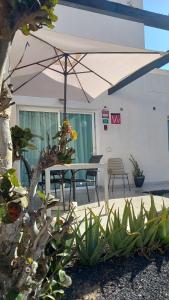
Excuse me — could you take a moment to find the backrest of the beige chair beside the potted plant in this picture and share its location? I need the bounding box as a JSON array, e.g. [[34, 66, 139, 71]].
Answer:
[[107, 158, 126, 175]]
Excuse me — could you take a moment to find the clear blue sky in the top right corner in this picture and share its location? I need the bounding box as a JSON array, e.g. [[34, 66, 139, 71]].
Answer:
[[144, 0, 169, 51]]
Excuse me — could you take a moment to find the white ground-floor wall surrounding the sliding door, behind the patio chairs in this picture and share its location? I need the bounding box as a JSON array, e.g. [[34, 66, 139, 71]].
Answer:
[[13, 71, 169, 183]]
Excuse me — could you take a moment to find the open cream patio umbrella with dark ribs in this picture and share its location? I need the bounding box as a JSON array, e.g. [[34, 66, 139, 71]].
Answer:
[[10, 29, 165, 118]]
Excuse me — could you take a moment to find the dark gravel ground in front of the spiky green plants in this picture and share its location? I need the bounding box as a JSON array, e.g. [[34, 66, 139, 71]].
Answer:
[[65, 253, 169, 300]]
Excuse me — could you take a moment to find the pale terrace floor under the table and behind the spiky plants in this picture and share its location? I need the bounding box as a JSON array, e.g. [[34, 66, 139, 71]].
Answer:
[[48, 183, 169, 220]]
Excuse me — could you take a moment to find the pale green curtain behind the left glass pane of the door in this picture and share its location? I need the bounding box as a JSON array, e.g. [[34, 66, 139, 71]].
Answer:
[[19, 111, 58, 186]]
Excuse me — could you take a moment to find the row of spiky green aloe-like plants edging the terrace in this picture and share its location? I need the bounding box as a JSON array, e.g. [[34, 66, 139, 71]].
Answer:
[[73, 196, 169, 265]]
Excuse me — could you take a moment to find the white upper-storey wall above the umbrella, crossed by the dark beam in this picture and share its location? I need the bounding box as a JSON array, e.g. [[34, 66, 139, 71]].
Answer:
[[54, 0, 144, 48]]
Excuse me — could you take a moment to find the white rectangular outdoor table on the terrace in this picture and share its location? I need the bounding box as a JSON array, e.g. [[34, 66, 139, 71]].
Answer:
[[45, 163, 109, 207]]
